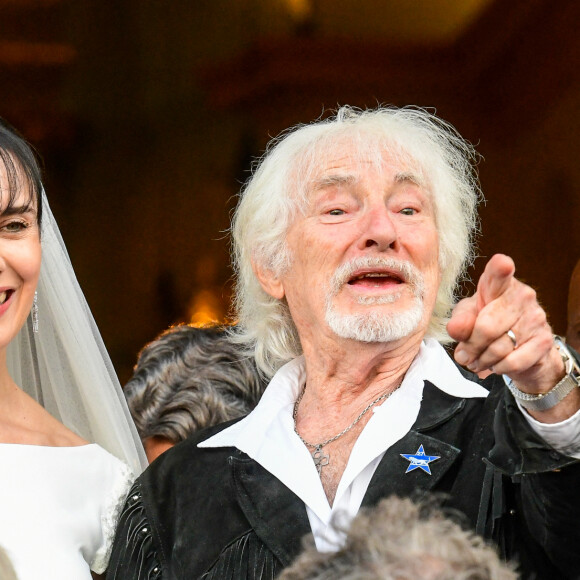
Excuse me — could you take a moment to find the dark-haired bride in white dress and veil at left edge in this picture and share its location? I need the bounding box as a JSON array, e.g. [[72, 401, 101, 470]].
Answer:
[[0, 120, 145, 580]]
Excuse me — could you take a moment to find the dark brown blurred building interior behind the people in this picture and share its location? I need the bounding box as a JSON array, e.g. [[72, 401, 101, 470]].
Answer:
[[0, 0, 580, 382]]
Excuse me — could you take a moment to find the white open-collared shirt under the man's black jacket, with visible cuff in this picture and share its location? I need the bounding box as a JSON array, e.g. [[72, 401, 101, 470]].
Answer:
[[199, 339, 580, 551]]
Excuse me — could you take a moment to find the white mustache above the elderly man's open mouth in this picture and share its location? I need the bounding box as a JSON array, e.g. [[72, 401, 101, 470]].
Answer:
[[330, 256, 425, 298]]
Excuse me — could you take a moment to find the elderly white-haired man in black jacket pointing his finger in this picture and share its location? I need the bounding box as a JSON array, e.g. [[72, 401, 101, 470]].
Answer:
[[108, 107, 580, 580]]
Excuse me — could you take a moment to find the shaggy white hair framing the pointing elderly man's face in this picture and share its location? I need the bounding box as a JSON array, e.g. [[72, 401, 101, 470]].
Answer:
[[232, 107, 481, 376]]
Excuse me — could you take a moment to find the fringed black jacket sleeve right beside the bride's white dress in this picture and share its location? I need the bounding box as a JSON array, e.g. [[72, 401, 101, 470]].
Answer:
[[107, 481, 164, 580]]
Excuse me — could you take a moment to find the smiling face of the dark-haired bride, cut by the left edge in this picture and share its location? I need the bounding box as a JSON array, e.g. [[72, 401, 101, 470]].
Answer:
[[0, 156, 41, 350]]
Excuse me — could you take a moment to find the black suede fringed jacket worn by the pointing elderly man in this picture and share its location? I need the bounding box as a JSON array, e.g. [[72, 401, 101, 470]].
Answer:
[[107, 375, 580, 580]]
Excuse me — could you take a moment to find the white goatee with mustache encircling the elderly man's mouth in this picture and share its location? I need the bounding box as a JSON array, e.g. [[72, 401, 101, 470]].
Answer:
[[326, 257, 424, 342]]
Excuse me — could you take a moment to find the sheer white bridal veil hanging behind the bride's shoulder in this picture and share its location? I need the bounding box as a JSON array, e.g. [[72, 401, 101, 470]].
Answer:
[[8, 192, 147, 475]]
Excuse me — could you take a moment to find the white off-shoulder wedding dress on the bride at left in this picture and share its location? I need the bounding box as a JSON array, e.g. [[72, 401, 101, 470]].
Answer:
[[0, 444, 133, 580]]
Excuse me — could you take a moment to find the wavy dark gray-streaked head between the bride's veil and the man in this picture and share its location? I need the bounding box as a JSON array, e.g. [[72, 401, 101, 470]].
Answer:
[[124, 325, 265, 461]]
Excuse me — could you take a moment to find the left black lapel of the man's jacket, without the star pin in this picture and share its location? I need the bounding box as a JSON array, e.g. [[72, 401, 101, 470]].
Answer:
[[230, 457, 311, 566]]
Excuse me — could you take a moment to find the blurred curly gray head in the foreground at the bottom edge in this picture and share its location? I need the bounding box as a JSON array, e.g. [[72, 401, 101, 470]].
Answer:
[[279, 496, 518, 580]]
